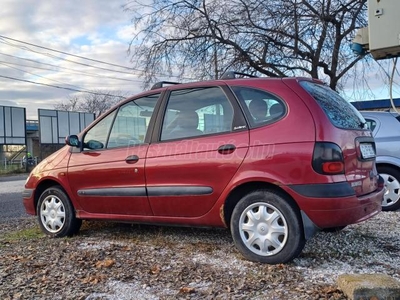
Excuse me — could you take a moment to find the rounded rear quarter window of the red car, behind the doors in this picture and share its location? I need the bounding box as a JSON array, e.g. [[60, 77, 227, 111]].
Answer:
[[231, 86, 286, 127]]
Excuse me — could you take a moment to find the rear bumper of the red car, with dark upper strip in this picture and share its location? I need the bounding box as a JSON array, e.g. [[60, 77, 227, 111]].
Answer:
[[289, 183, 384, 229]]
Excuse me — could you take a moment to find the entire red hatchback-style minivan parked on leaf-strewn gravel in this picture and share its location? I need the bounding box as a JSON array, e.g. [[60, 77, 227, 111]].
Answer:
[[23, 74, 384, 264]]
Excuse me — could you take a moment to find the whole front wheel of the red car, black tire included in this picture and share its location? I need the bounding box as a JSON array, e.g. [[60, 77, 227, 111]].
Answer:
[[37, 186, 82, 237]]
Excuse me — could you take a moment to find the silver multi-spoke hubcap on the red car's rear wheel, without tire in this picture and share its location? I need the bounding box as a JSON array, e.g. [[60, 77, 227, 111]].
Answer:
[[239, 202, 288, 256]]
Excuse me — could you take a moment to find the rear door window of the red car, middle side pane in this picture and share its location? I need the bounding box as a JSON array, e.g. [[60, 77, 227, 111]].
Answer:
[[161, 87, 233, 140]]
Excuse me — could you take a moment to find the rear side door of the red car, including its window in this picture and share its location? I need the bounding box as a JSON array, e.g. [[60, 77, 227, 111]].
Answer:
[[146, 86, 249, 217]]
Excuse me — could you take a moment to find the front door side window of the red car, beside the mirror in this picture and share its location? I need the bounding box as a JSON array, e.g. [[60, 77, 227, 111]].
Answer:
[[83, 94, 159, 149]]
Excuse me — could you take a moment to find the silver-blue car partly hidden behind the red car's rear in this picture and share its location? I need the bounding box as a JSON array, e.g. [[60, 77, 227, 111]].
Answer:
[[361, 111, 400, 211]]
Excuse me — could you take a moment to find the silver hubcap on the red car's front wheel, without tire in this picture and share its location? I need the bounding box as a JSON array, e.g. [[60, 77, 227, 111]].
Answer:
[[40, 195, 65, 233]]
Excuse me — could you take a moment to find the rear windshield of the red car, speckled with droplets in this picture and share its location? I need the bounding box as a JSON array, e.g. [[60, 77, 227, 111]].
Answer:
[[300, 81, 367, 129]]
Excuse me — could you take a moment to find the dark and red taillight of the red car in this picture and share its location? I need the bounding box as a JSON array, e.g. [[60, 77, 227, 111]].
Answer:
[[312, 142, 344, 175]]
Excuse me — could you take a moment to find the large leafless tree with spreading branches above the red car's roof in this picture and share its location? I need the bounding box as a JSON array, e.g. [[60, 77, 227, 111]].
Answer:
[[124, 0, 367, 89]]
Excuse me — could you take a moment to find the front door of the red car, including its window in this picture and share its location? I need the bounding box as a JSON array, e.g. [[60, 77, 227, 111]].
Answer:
[[68, 94, 159, 215]]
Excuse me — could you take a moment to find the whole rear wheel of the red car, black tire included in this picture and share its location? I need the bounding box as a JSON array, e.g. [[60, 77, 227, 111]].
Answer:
[[230, 190, 305, 264]]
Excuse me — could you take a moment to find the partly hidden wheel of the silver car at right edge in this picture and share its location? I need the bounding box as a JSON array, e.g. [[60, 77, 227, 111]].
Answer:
[[377, 166, 400, 211]]
